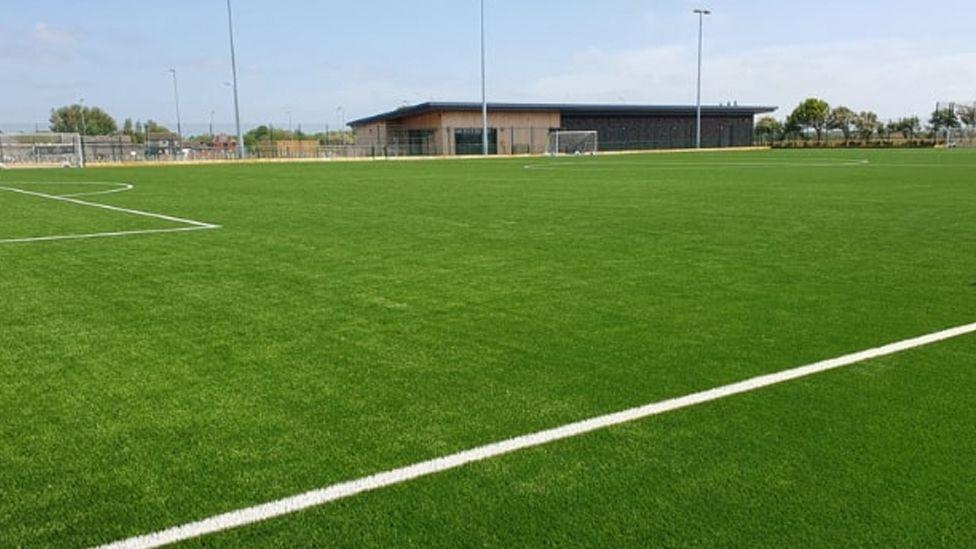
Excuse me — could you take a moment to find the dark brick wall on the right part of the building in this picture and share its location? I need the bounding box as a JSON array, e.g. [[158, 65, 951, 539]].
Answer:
[[562, 115, 753, 151]]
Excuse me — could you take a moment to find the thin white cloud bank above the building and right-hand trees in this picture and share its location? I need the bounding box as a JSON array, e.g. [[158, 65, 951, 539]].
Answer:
[[519, 40, 976, 118]]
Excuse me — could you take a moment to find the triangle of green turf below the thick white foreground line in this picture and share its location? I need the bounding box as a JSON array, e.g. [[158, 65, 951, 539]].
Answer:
[[202, 340, 976, 547]]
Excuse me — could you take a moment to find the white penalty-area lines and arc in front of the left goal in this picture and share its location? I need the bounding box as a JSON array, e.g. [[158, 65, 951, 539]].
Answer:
[[0, 182, 220, 244]]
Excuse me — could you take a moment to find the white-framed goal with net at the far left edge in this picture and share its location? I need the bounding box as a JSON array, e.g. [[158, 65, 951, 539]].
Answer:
[[0, 133, 85, 168]]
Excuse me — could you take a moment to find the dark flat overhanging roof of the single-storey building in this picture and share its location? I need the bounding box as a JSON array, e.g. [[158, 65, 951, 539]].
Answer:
[[349, 102, 776, 127]]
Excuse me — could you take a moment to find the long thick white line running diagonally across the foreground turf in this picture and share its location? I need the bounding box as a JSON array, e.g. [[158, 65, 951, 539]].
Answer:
[[100, 323, 976, 549]]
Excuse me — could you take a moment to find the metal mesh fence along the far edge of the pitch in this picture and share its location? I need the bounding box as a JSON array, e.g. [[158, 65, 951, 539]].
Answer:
[[11, 122, 964, 166]]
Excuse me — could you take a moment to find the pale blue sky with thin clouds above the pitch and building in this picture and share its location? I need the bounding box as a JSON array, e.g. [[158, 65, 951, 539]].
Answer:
[[0, 0, 976, 133]]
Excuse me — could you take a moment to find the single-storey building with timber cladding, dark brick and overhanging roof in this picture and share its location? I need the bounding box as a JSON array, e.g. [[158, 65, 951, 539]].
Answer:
[[350, 102, 776, 156]]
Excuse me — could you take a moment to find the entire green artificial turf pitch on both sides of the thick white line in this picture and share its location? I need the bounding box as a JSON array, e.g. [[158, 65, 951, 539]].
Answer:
[[0, 151, 976, 546]]
